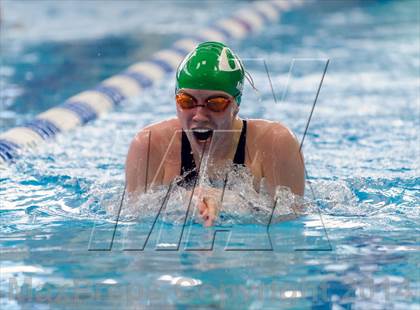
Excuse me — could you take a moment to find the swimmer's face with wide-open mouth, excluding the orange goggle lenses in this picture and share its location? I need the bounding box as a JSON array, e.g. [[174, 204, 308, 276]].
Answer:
[[176, 88, 239, 141]]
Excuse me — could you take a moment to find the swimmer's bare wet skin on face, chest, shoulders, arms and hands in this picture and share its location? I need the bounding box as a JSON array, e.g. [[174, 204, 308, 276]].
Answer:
[[126, 89, 305, 226]]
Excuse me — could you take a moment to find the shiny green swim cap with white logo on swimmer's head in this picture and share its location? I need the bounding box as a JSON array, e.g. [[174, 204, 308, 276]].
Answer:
[[176, 42, 245, 105]]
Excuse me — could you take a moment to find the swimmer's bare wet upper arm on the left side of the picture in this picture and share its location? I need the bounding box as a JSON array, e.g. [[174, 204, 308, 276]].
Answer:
[[125, 130, 163, 193]]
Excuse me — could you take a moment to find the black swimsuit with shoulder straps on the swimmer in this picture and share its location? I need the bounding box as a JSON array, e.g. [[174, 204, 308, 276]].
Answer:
[[178, 120, 246, 187]]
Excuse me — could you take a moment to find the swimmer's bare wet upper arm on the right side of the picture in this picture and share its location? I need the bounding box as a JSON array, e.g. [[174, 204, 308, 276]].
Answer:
[[262, 124, 305, 197]]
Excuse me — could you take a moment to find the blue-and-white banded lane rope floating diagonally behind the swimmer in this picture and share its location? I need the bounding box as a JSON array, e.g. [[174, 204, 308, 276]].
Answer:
[[0, 0, 306, 164]]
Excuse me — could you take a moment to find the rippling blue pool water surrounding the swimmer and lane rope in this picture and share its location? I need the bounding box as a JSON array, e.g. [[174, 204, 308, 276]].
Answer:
[[0, 1, 420, 309]]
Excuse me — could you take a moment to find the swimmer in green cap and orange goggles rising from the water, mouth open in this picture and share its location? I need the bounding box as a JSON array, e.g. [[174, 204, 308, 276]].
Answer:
[[126, 42, 305, 226]]
